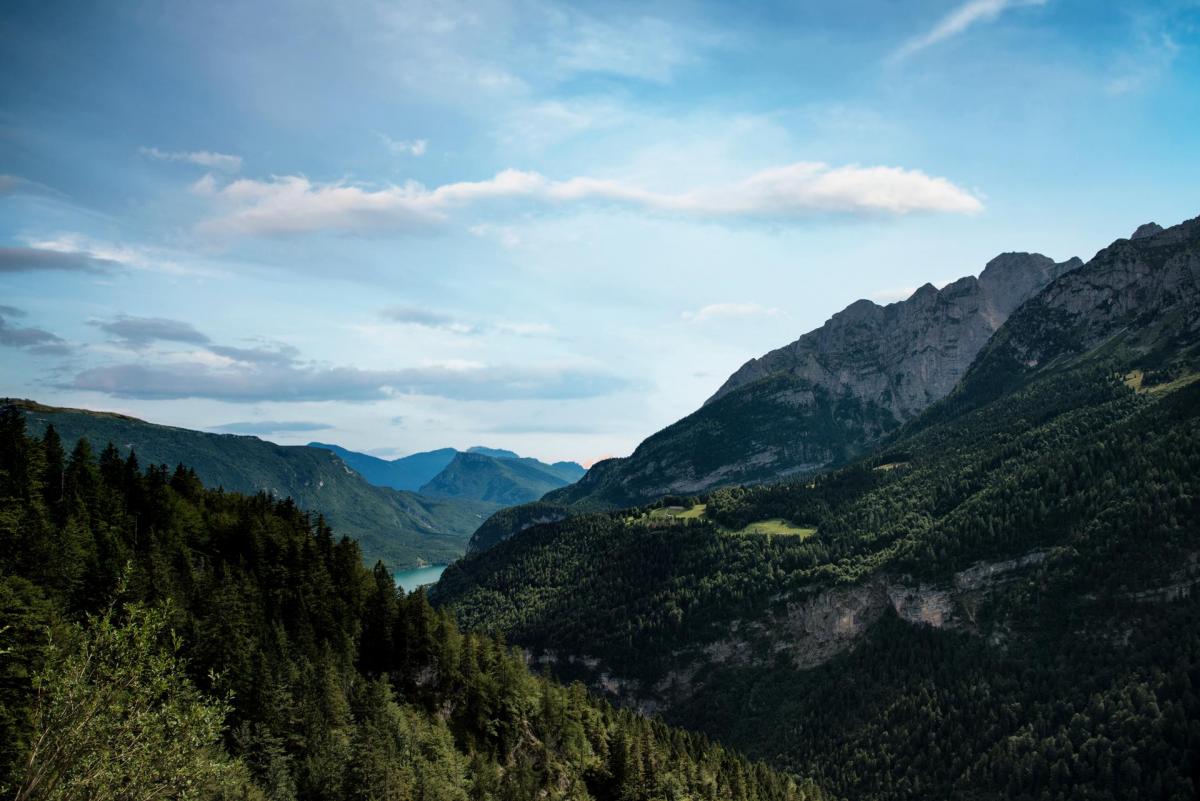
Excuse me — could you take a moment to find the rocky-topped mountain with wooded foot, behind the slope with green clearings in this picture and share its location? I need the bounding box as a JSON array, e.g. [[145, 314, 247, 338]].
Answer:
[[542, 253, 1082, 511]]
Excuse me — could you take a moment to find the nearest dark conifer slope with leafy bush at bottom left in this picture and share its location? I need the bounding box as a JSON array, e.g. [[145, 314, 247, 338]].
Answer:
[[0, 405, 823, 801]]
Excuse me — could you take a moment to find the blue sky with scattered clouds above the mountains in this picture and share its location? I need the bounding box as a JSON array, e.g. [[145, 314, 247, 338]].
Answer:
[[0, 0, 1200, 464]]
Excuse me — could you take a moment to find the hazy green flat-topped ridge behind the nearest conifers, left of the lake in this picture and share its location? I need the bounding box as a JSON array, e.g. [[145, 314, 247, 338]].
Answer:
[[10, 401, 498, 568]]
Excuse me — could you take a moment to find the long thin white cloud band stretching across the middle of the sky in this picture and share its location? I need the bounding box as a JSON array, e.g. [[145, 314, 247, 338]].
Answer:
[[200, 162, 983, 236]]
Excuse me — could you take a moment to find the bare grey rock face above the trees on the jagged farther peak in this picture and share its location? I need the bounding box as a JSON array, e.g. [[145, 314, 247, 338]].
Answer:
[[707, 253, 1082, 422]]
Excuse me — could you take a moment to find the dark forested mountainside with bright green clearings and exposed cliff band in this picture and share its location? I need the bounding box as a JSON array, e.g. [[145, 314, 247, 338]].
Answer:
[[433, 215, 1200, 799]]
